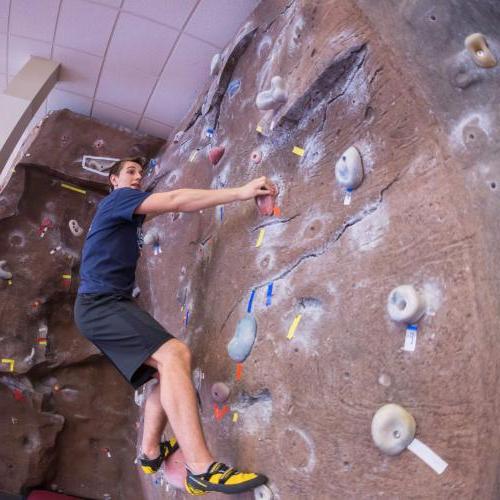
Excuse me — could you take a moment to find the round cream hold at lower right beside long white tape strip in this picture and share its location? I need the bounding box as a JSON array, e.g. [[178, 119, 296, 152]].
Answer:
[[372, 403, 416, 455]]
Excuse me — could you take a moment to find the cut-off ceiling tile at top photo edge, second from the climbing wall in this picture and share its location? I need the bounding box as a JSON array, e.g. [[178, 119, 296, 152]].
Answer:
[[122, 0, 196, 29]]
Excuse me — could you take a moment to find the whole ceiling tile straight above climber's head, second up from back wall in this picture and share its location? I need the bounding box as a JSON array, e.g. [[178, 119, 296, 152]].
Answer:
[[96, 68, 156, 113]]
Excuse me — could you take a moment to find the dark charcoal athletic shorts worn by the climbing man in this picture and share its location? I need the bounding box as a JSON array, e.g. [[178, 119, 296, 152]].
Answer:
[[74, 293, 174, 389]]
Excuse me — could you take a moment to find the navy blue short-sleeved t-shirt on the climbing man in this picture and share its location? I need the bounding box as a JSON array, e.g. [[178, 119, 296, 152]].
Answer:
[[78, 188, 151, 294]]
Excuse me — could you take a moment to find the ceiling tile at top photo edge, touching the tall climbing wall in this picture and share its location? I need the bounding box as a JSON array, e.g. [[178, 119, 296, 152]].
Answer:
[[185, 0, 259, 47]]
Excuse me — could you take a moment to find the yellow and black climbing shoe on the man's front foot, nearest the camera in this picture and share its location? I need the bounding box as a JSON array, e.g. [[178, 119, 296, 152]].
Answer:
[[185, 462, 267, 495]]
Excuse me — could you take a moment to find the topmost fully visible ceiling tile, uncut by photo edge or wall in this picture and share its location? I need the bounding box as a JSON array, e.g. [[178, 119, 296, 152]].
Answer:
[[105, 13, 178, 76]]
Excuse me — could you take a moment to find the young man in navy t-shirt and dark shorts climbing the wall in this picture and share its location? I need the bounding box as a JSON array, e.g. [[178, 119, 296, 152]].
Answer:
[[75, 158, 275, 495]]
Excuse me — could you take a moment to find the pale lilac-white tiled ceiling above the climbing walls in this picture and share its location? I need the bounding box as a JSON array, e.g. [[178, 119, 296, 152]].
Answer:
[[0, 0, 260, 138]]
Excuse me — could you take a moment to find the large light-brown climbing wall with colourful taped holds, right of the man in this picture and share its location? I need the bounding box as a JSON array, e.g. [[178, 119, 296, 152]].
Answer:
[[134, 0, 500, 500]]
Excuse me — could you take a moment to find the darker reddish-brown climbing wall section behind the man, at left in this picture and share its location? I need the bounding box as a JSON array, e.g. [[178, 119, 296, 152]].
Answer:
[[0, 111, 162, 500]]
